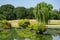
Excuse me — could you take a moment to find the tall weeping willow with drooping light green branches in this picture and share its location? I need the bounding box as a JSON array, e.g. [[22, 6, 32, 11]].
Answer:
[[34, 2, 53, 23]]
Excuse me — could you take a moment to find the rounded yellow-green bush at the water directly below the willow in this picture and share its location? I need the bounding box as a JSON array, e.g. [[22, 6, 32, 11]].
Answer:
[[33, 23, 46, 34]]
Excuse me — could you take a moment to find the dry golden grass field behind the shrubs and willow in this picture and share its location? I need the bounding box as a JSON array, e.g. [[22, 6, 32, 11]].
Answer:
[[8, 19, 60, 27]]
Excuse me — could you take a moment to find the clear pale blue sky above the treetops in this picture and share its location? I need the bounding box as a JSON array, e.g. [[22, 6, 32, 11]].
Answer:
[[0, 0, 60, 9]]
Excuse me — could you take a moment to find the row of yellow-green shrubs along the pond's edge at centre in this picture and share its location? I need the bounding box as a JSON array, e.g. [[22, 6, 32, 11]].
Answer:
[[19, 19, 46, 34]]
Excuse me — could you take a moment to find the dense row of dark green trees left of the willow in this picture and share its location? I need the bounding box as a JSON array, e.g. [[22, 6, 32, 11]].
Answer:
[[0, 4, 34, 20]]
